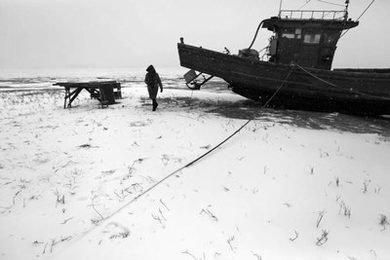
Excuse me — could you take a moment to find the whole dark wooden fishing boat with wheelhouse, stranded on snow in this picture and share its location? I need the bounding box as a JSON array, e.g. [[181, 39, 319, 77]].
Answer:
[[177, 0, 390, 115]]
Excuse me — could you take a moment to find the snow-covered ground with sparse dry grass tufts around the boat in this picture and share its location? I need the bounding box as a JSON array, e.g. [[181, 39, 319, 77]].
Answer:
[[0, 77, 390, 260]]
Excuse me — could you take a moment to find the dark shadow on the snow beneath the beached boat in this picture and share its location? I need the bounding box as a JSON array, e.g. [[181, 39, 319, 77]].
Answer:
[[143, 94, 390, 137]]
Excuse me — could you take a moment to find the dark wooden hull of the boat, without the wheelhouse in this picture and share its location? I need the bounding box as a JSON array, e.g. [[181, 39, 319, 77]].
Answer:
[[178, 43, 390, 115]]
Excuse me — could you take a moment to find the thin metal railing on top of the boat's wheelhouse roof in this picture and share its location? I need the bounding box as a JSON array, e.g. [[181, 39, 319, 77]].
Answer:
[[279, 10, 348, 20]]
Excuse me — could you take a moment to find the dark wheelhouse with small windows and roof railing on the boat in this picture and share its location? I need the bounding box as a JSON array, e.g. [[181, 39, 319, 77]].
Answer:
[[262, 10, 359, 70]]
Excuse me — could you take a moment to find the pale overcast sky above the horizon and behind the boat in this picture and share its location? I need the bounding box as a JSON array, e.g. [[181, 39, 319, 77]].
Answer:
[[0, 0, 390, 69]]
